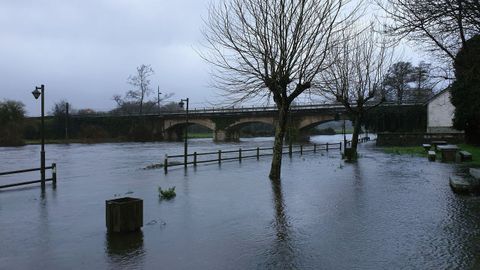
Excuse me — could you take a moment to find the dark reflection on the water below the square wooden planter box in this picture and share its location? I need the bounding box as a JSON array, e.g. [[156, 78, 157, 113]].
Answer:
[[105, 230, 145, 269]]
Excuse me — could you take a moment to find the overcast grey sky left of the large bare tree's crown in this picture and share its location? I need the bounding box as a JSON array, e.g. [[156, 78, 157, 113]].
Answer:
[[0, 0, 424, 115]]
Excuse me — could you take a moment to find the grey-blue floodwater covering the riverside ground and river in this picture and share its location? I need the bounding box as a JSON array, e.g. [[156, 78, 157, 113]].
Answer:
[[0, 136, 480, 269]]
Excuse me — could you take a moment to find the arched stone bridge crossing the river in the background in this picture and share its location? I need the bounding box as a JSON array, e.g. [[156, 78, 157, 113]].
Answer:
[[159, 105, 346, 141]]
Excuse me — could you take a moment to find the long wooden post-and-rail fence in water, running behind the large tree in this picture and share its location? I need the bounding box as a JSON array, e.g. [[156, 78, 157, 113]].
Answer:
[[163, 142, 342, 173]]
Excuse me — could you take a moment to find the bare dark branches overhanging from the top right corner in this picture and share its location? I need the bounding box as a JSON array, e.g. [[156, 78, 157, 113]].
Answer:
[[376, 0, 480, 63]]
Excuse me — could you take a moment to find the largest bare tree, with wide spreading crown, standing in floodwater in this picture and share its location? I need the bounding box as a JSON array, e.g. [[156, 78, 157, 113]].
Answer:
[[202, 0, 358, 180]]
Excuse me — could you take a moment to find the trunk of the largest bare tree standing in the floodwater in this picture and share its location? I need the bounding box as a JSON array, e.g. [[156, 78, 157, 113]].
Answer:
[[269, 104, 289, 180]]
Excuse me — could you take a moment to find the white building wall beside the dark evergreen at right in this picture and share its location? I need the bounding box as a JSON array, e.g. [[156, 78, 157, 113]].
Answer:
[[427, 88, 459, 133]]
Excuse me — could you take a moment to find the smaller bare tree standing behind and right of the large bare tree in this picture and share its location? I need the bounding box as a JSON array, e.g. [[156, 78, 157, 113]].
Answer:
[[319, 27, 393, 154]]
